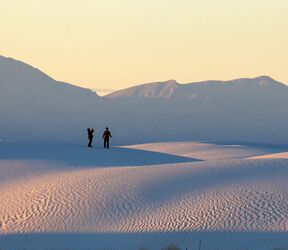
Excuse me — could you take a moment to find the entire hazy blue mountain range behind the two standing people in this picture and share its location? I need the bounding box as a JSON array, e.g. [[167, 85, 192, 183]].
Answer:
[[0, 56, 288, 144]]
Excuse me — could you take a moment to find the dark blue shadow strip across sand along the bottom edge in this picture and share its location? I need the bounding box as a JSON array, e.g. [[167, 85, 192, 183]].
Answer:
[[0, 231, 288, 250]]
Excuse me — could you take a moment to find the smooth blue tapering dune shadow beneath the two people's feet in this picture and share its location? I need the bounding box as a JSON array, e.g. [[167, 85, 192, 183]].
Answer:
[[0, 143, 200, 167]]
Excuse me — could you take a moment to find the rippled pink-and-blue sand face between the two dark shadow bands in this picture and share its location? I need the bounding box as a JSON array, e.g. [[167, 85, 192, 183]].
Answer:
[[0, 159, 288, 233]]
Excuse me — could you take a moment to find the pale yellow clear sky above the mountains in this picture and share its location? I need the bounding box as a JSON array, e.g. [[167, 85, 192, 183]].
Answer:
[[0, 0, 288, 92]]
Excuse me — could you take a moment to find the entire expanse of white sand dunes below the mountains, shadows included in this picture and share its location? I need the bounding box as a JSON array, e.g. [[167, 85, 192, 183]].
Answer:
[[0, 142, 288, 249]]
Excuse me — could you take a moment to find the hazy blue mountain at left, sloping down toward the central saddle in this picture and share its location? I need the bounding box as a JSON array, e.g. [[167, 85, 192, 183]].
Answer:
[[0, 57, 100, 143]]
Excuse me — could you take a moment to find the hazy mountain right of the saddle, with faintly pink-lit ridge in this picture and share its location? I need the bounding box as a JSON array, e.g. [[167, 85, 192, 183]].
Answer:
[[104, 76, 288, 143]]
